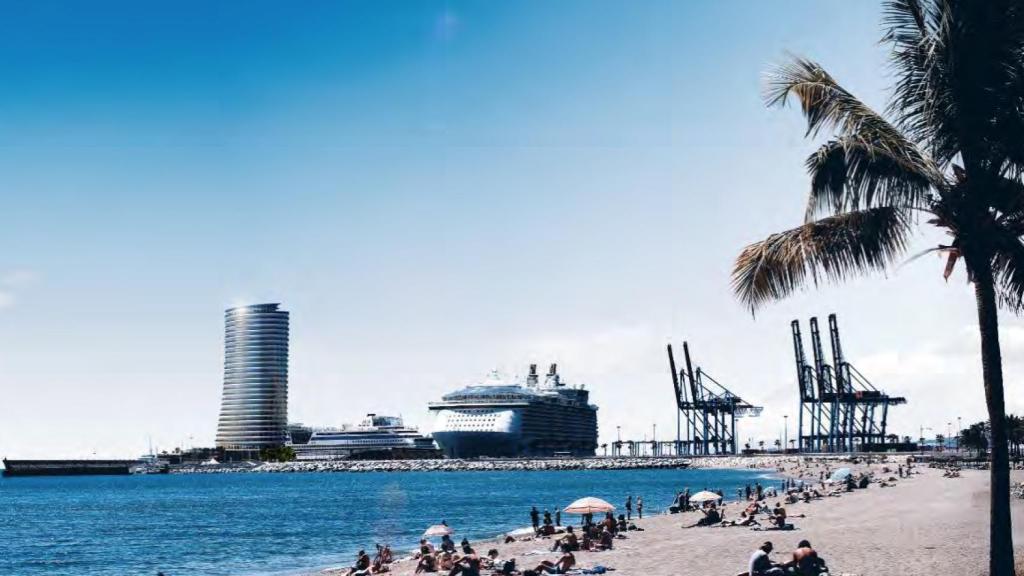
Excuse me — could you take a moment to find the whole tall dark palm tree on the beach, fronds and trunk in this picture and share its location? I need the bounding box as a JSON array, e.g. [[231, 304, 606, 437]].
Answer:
[[733, 0, 1024, 574]]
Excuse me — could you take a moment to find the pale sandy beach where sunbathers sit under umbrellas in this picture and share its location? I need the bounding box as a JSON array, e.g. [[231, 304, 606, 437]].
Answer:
[[323, 464, 1024, 576]]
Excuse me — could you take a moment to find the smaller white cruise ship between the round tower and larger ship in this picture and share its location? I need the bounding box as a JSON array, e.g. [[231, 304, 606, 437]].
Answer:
[[291, 414, 438, 460]]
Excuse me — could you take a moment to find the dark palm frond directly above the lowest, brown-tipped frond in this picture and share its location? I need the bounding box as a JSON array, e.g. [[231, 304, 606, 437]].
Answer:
[[806, 136, 945, 221]]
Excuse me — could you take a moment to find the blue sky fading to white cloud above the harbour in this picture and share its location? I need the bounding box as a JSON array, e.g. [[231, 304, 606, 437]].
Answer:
[[0, 0, 1024, 457]]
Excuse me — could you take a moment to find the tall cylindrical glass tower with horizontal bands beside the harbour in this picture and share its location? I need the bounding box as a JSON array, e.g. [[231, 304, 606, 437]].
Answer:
[[217, 303, 288, 451]]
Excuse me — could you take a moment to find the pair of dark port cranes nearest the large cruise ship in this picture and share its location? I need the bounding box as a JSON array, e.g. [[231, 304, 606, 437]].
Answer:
[[668, 342, 762, 455]]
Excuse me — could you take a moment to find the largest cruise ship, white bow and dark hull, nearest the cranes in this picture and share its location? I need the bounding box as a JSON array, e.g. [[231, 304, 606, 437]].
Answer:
[[429, 364, 597, 458]]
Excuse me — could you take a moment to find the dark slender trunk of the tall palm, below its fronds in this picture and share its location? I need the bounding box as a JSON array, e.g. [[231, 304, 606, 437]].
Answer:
[[974, 259, 1014, 576]]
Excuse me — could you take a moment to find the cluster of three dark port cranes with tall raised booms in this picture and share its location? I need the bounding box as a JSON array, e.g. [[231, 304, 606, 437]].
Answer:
[[791, 314, 906, 452]]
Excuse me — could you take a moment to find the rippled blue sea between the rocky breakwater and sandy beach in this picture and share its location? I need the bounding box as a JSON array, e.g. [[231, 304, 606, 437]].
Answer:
[[0, 470, 767, 576]]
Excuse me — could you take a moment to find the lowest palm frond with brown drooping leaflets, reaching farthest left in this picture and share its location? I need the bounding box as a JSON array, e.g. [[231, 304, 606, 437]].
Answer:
[[732, 206, 909, 312]]
